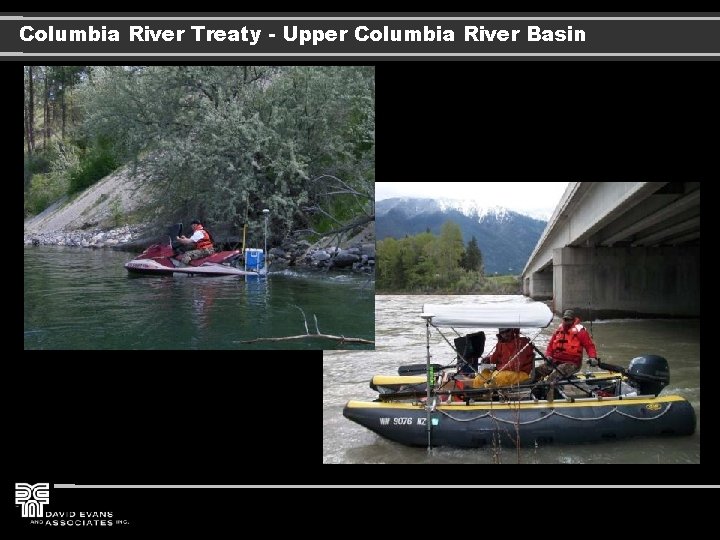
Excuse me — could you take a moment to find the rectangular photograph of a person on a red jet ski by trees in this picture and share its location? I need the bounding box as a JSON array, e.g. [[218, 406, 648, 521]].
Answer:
[[23, 65, 375, 350]]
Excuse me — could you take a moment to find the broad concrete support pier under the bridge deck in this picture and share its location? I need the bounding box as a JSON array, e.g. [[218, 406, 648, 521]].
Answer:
[[552, 246, 700, 319]]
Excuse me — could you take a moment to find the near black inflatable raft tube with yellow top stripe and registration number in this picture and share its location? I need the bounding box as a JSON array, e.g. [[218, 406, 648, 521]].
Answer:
[[343, 396, 696, 448]]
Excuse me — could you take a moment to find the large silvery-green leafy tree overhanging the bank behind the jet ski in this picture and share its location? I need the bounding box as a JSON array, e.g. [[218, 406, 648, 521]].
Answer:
[[75, 66, 375, 240]]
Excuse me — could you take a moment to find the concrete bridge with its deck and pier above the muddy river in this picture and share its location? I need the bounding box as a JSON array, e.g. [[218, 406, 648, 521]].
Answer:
[[522, 182, 700, 319]]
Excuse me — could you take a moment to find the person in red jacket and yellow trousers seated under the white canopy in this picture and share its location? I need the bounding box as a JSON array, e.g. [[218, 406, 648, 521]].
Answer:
[[473, 328, 535, 387]]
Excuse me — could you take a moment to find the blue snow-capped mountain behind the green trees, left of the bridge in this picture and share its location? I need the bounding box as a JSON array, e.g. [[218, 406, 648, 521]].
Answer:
[[375, 197, 547, 275]]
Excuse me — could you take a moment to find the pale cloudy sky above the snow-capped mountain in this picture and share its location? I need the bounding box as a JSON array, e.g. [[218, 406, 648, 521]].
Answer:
[[375, 182, 568, 219]]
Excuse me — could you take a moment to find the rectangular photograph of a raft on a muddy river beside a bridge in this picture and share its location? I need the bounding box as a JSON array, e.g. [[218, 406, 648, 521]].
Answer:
[[323, 181, 700, 464]]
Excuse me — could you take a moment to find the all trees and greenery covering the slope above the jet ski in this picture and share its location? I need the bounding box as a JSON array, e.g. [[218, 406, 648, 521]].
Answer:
[[24, 66, 375, 245]]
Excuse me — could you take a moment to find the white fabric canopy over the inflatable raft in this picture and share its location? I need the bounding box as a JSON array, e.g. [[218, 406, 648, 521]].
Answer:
[[420, 302, 553, 328]]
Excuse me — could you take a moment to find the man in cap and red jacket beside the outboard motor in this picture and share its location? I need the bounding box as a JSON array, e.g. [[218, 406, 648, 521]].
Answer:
[[535, 309, 597, 382]]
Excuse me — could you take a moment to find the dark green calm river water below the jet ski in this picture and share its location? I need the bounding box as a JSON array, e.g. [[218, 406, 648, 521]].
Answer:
[[24, 246, 375, 350]]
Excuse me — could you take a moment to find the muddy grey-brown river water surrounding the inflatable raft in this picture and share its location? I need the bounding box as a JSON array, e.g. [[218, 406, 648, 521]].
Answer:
[[323, 295, 700, 464]]
